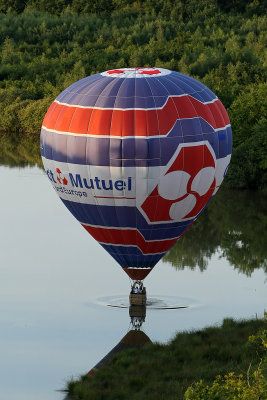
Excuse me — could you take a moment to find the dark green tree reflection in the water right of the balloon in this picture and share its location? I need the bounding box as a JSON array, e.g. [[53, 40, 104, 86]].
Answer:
[[163, 188, 267, 276]]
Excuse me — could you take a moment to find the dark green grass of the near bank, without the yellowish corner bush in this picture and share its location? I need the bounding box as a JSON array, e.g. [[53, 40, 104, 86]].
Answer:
[[68, 319, 267, 400]]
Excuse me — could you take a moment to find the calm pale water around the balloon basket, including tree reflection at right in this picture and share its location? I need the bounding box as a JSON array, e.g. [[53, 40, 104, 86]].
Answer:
[[0, 160, 267, 400]]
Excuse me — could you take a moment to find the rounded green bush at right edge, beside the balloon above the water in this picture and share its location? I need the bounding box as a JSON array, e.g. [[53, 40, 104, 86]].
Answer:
[[227, 83, 267, 188]]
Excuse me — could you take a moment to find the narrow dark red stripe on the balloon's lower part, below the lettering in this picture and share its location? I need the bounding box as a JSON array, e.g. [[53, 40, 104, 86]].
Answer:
[[82, 224, 178, 254]]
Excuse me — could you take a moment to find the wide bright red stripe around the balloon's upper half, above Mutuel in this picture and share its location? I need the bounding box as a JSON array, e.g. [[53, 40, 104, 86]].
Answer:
[[43, 95, 230, 137]]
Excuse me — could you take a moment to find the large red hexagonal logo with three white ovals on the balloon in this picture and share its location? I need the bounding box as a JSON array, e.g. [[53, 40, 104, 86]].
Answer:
[[141, 144, 216, 222]]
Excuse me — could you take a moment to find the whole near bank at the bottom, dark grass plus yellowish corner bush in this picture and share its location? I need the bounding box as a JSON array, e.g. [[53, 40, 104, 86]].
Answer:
[[67, 314, 267, 400]]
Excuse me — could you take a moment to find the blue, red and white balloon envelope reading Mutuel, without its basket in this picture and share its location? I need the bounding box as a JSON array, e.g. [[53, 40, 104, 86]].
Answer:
[[40, 68, 232, 296]]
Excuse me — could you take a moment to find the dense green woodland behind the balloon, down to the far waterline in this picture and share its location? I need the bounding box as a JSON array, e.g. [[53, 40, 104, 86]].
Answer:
[[0, 0, 267, 188]]
